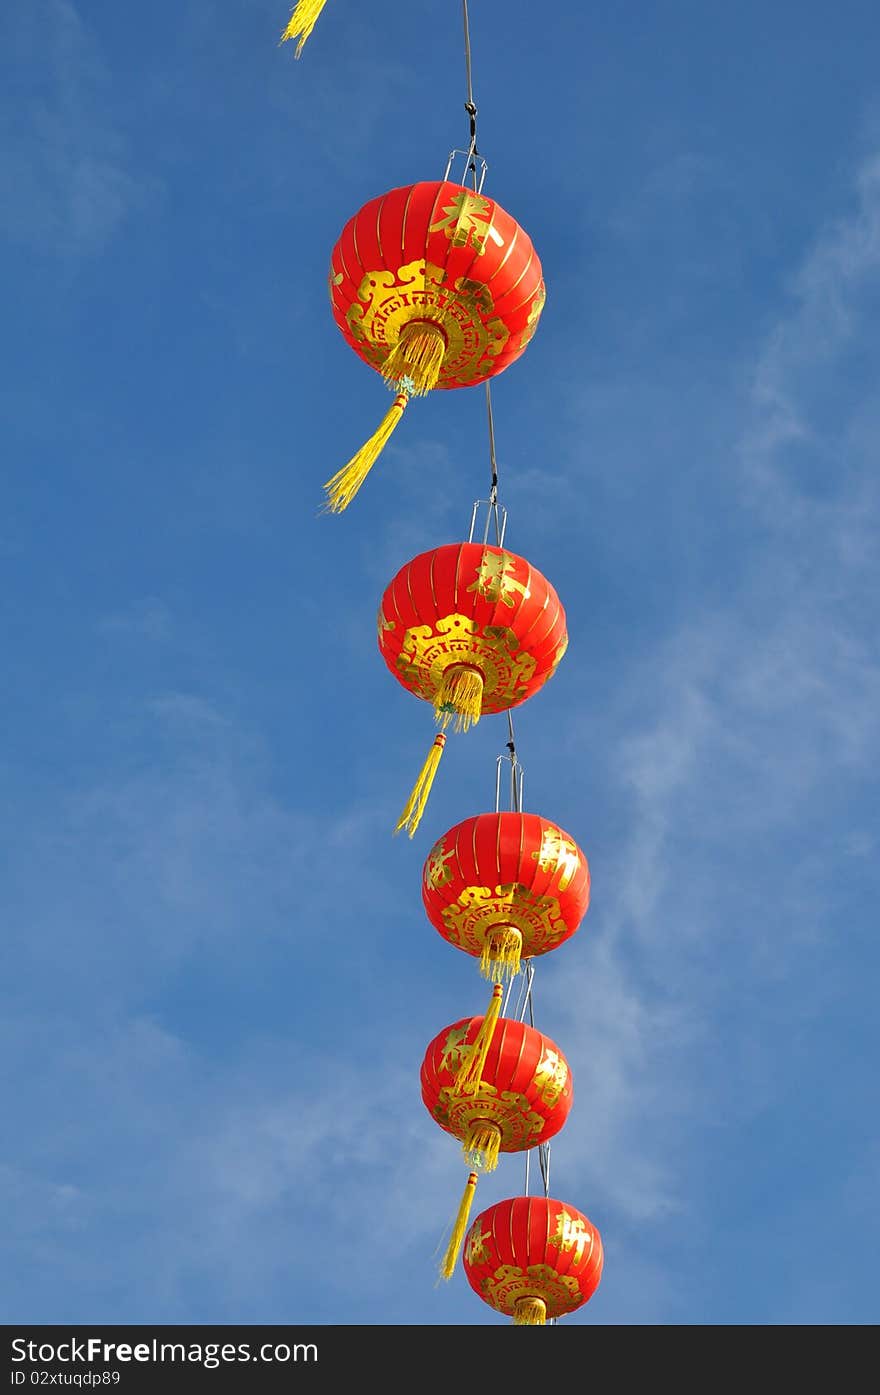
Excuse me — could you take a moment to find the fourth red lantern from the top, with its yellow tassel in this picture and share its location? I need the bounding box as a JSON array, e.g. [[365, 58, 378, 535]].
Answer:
[[421, 1017, 572, 1278]]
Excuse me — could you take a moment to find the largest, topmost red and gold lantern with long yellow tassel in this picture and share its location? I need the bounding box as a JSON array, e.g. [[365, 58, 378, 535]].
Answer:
[[325, 180, 545, 513]]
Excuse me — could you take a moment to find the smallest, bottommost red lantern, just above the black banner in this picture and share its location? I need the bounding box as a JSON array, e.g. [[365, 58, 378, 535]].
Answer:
[[463, 1197, 604, 1325]]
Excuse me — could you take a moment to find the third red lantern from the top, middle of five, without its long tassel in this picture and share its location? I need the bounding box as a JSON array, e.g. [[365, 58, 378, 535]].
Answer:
[[421, 812, 590, 979]]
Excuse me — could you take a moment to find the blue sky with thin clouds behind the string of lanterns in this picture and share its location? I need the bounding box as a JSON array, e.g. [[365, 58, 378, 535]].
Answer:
[[0, 0, 880, 1325]]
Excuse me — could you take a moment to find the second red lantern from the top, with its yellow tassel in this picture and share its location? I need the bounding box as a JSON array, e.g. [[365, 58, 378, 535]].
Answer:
[[378, 543, 568, 837]]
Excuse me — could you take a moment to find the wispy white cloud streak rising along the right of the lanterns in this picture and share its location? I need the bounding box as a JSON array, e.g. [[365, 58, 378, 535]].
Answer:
[[537, 147, 880, 1272]]
